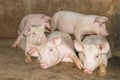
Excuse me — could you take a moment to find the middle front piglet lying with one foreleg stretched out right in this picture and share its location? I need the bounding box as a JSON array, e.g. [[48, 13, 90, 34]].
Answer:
[[30, 31, 82, 69]]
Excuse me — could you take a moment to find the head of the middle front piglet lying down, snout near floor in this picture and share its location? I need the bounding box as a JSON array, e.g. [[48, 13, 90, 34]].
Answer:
[[40, 36, 61, 69]]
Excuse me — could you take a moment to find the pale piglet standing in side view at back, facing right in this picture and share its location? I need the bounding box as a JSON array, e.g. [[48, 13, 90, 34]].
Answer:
[[51, 11, 109, 41]]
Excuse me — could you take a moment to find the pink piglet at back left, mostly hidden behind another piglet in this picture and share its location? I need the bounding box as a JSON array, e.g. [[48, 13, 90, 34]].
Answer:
[[12, 14, 51, 48]]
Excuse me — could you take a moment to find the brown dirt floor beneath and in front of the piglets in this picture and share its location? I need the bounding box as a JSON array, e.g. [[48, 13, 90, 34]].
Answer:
[[0, 39, 120, 80]]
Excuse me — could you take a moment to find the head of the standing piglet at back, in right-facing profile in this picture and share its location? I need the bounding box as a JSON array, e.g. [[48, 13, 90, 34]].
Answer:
[[92, 16, 109, 36]]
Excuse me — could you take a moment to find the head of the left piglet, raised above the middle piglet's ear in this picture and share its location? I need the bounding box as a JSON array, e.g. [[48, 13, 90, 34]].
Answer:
[[24, 25, 46, 45]]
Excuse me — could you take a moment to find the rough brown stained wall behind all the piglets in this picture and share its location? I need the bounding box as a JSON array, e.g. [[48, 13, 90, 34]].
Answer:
[[0, 0, 120, 56]]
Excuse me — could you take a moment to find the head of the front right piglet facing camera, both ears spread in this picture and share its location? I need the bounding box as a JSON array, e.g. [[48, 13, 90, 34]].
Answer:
[[74, 41, 109, 74]]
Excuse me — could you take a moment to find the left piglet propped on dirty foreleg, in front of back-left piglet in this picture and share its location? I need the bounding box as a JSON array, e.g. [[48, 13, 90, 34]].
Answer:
[[13, 25, 46, 63]]
